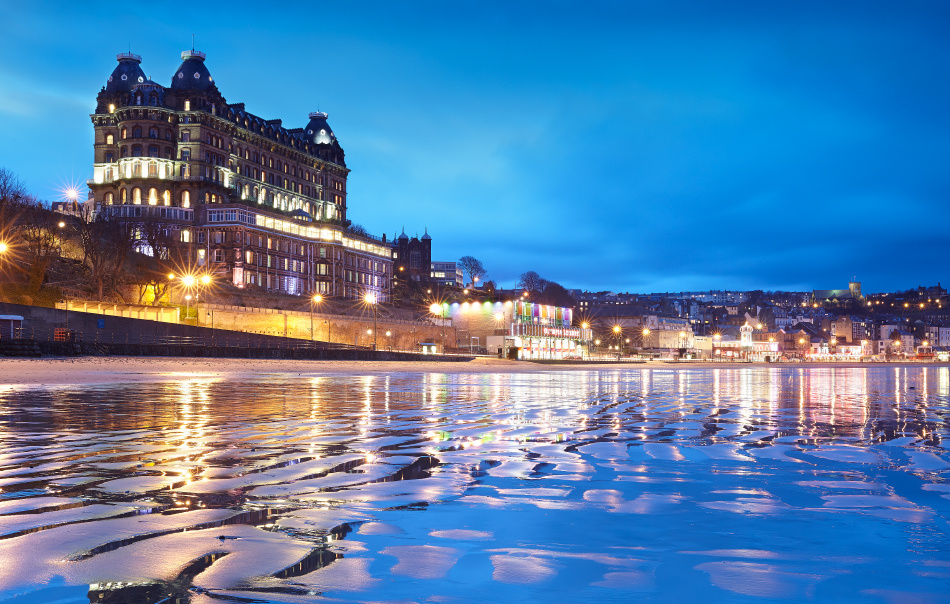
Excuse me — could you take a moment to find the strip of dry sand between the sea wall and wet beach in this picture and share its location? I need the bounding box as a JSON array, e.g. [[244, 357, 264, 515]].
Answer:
[[0, 357, 948, 386]]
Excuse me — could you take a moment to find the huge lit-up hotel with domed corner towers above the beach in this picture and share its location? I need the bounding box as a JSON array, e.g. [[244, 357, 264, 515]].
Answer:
[[89, 50, 393, 301]]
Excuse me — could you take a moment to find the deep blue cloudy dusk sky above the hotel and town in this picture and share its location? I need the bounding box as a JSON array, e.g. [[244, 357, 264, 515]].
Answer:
[[0, 0, 950, 292]]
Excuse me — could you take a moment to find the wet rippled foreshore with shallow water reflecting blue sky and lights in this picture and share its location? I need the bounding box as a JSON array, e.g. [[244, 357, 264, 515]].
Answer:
[[0, 367, 950, 604]]
